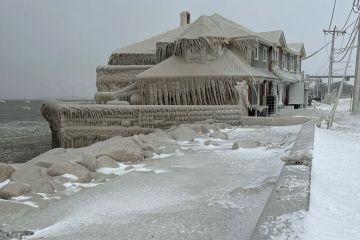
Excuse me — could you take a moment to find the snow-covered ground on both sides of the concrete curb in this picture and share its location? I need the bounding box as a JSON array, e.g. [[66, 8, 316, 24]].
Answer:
[[0, 99, 360, 240]]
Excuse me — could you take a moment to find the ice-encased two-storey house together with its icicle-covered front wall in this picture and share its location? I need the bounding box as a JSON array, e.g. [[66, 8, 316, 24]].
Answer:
[[42, 12, 304, 147]]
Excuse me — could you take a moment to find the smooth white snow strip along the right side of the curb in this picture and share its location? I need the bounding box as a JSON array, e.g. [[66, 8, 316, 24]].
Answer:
[[304, 124, 360, 240]]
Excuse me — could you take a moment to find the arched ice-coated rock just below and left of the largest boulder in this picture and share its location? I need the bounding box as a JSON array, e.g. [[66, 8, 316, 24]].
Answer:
[[47, 162, 91, 182]]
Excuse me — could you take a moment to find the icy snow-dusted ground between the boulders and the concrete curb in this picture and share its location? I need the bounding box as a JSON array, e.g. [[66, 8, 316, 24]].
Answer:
[[0, 123, 300, 239]]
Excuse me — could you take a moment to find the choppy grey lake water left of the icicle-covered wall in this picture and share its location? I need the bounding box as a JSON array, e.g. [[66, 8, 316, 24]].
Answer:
[[0, 100, 51, 163]]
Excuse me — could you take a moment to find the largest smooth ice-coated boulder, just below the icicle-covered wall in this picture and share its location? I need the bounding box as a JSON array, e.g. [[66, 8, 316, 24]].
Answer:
[[77, 136, 144, 162]]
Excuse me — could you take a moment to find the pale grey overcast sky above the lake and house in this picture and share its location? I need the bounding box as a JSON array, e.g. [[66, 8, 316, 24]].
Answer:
[[0, 0, 355, 99]]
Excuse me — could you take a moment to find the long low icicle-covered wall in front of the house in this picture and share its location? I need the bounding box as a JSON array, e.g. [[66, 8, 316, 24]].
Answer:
[[41, 102, 308, 148]]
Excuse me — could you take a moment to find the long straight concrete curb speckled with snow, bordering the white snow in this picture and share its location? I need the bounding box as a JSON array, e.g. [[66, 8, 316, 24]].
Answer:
[[250, 121, 315, 240]]
